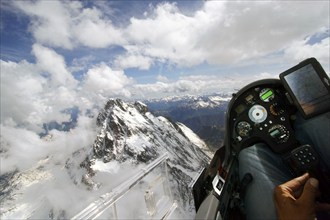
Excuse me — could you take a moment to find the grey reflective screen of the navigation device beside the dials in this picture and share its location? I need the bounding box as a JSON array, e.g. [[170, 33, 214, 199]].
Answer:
[[284, 64, 330, 115]]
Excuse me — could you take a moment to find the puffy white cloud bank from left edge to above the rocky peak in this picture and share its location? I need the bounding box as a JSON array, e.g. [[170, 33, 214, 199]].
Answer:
[[0, 44, 132, 133]]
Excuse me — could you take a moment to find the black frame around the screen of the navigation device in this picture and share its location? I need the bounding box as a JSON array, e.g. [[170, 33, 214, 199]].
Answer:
[[280, 58, 330, 119]]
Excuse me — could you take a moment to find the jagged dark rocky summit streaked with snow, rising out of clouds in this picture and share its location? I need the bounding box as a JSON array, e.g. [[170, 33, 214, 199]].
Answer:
[[93, 99, 207, 167]]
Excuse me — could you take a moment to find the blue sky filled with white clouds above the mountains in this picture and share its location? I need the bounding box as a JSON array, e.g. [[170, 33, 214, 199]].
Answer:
[[0, 0, 330, 170]]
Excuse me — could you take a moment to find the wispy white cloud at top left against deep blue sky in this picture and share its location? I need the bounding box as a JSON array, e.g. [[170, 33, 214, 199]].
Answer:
[[14, 1, 125, 49]]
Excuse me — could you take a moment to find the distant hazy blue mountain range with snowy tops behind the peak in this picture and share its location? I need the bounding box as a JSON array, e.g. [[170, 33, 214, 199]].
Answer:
[[145, 94, 231, 149]]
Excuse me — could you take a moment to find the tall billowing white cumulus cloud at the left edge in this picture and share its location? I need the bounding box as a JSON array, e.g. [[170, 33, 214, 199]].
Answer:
[[1, 44, 85, 132]]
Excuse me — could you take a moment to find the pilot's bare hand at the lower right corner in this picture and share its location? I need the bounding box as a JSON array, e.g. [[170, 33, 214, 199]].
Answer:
[[274, 173, 330, 220]]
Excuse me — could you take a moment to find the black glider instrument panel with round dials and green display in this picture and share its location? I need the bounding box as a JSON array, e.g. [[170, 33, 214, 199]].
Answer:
[[229, 84, 295, 153]]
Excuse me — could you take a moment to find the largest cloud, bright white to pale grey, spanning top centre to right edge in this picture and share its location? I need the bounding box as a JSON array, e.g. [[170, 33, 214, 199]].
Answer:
[[122, 1, 329, 66]]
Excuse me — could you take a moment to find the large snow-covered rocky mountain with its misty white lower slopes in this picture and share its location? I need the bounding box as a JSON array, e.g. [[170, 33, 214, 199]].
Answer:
[[0, 99, 212, 219]]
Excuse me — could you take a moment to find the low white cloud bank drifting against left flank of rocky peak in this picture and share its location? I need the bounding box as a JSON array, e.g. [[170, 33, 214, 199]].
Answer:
[[0, 115, 96, 173]]
